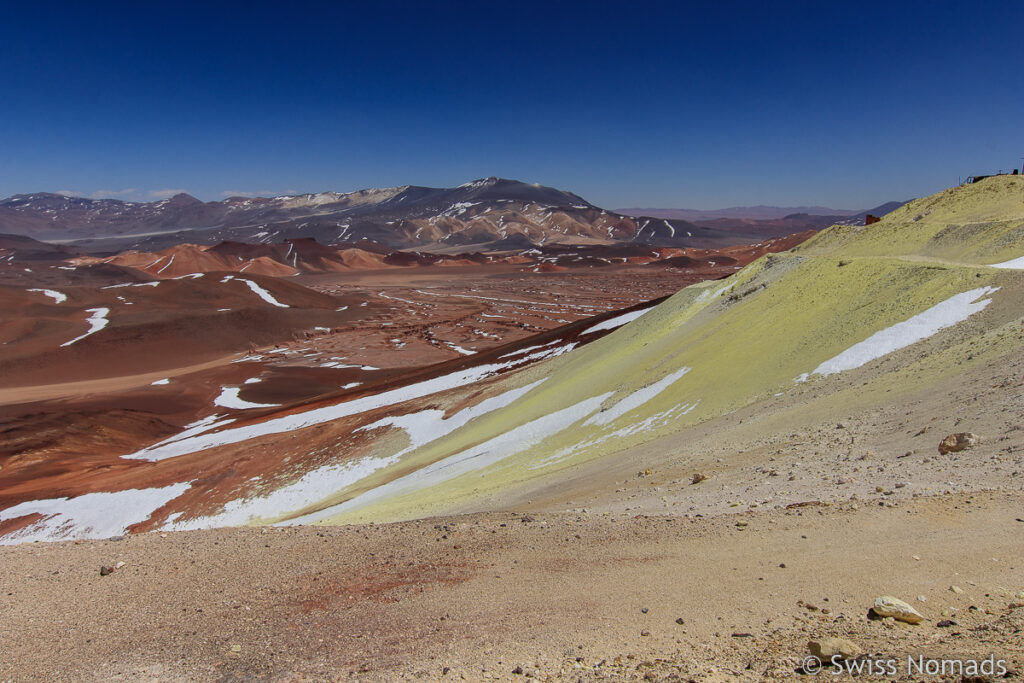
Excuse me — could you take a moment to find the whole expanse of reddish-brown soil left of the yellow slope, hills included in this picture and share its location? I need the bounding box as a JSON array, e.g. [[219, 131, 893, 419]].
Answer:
[[0, 236, 806, 532]]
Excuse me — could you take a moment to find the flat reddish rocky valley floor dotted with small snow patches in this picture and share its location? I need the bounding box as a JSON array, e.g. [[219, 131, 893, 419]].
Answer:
[[286, 265, 704, 368]]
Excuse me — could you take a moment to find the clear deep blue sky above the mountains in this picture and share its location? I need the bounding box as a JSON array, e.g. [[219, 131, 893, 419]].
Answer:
[[0, 0, 1024, 208]]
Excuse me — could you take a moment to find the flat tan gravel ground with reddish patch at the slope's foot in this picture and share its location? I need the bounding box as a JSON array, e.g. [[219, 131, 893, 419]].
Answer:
[[0, 492, 1024, 681]]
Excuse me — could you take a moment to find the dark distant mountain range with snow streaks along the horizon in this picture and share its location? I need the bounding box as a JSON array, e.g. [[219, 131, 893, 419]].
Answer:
[[0, 177, 897, 253]]
